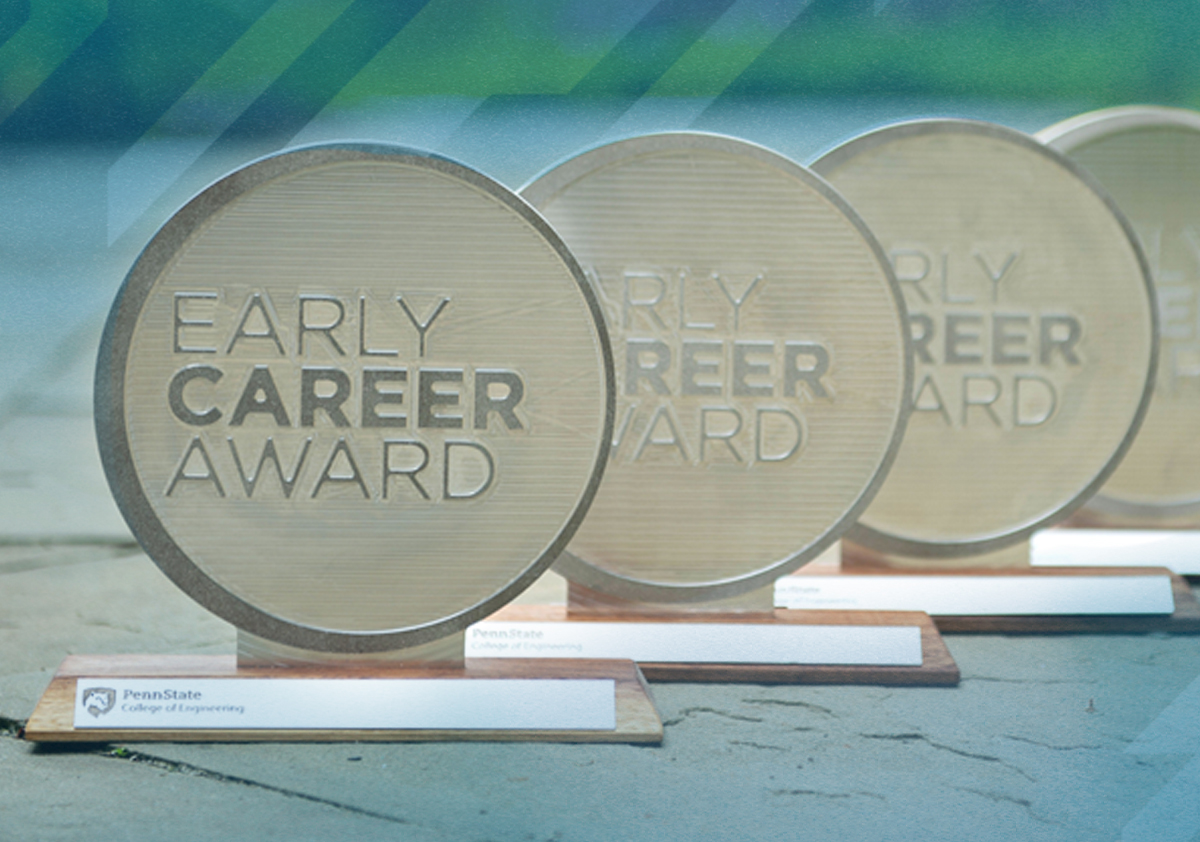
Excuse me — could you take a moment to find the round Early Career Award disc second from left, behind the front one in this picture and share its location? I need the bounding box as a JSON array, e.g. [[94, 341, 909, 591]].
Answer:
[[522, 133, 911, 602]]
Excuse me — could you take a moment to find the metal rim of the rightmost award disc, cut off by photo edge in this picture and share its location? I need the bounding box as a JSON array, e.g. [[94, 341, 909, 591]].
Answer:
[[1033, 106, 1200, 519]]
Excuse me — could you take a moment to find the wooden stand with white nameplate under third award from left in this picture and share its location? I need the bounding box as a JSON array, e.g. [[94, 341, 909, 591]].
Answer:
[[779, 542, 1200, 633]]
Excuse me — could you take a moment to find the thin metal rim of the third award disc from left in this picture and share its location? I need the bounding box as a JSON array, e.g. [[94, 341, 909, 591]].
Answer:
[[811, 118, 1158, 558]]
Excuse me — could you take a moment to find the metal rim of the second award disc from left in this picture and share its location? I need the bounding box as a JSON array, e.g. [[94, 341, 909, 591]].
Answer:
[[518, 132, 914, 603]]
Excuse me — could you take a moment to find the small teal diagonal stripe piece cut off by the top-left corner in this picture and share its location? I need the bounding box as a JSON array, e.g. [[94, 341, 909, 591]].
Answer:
[[0, 0, 108, 122]]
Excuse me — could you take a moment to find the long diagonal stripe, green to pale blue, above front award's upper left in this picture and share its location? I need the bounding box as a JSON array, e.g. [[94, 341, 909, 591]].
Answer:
[[108, 0, 350, 243]]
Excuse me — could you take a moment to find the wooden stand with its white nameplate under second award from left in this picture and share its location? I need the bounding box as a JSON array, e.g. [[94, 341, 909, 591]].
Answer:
[[467, 583, 959, 686]]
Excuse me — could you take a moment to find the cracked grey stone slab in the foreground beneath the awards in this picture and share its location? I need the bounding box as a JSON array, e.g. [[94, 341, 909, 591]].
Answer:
[[0, 547, 1200, 842]]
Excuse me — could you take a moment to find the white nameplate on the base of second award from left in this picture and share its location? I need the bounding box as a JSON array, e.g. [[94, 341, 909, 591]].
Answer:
[[466, 620, 922, 667]]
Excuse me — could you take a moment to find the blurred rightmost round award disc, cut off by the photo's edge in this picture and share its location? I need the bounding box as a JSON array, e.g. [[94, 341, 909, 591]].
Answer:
[[1037, 107, 1200, 523]]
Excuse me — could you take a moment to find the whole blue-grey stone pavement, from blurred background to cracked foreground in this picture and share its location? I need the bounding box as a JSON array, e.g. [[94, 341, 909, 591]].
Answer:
[[0, 103, 1200, 842]]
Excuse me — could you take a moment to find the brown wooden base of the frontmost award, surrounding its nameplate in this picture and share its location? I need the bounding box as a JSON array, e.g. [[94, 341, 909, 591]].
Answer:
[[24, 655, 662, 744]]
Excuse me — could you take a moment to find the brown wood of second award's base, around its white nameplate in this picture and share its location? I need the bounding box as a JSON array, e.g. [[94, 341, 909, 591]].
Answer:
[[488, 605, 959, 686]]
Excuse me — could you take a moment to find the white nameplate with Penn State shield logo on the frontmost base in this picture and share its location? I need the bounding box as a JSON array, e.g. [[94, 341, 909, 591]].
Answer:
[[74, 678, 617, 730]]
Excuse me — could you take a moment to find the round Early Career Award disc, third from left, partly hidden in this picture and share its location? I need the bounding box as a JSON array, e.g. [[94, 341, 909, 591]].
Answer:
[[814, 120, 1156, 557]]
